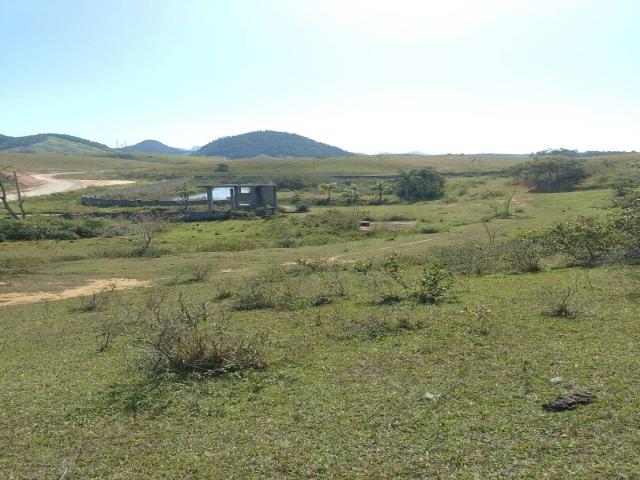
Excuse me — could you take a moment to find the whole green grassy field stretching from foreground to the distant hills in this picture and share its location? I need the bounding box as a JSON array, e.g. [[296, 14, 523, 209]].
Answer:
[[0, 154, 640, 479]]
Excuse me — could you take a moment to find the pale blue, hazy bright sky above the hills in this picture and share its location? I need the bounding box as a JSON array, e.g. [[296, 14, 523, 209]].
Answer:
[[0, 0, 640, 153]]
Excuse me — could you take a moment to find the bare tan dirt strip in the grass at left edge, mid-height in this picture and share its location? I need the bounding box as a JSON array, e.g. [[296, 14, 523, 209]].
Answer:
[[0, 278, 151, 306]]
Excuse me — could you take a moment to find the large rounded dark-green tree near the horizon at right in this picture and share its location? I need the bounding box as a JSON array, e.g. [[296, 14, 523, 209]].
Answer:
[[511, 156, 587, 192]]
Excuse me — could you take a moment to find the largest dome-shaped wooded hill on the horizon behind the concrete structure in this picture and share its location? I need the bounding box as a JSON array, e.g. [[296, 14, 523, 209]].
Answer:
[[193, 130, 352, 159]]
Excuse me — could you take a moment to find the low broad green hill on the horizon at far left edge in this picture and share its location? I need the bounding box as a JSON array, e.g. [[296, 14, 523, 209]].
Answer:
[[0, 133, 111, 155]]
